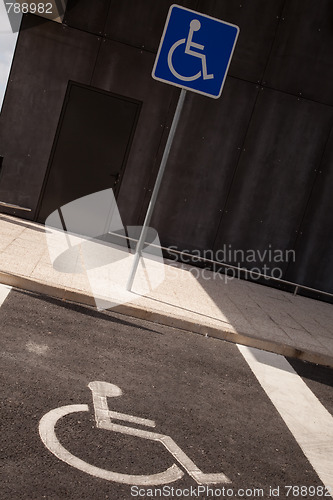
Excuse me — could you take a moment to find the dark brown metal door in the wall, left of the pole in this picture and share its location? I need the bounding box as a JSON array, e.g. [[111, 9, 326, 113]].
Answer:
[[38, 82, 141, 223]]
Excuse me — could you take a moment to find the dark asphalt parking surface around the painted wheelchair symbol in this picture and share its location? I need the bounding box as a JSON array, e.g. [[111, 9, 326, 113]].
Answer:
[[0, 290, 333, 500]]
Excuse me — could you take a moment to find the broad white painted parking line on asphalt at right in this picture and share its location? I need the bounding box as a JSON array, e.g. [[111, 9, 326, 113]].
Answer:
[[238, 345, 333, 496]]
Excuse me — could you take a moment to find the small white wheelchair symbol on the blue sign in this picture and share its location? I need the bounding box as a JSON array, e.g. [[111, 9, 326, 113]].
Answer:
[[168, 19, 214, 82]]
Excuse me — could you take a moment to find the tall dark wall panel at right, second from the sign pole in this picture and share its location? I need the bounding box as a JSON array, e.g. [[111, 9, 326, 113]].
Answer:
[[211, 90, 333, 269]]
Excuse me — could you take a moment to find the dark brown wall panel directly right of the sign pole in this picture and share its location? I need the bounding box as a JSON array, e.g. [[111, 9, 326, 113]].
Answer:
[[148, 78, 258, 249]]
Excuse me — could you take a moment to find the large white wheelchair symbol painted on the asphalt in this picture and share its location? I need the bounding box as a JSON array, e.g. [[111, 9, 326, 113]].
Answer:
[[39, 382, 231, 486]]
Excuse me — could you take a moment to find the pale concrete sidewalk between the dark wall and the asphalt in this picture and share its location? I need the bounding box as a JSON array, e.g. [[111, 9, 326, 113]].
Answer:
[[0, 214, 333, 367]]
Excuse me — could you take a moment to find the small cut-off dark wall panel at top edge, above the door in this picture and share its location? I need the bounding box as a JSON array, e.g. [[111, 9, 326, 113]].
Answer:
[[64, 0, 110, 35]]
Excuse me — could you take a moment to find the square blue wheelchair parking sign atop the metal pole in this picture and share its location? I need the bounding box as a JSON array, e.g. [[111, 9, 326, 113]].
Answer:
[[152, 5, 239, 98]]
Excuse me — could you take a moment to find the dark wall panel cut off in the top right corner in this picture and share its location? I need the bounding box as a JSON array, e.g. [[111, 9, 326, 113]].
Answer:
[[264, 0, 333, 105]]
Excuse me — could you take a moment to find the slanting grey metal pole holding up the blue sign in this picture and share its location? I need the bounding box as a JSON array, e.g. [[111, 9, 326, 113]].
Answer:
[[126, 89, 186, 291]]
